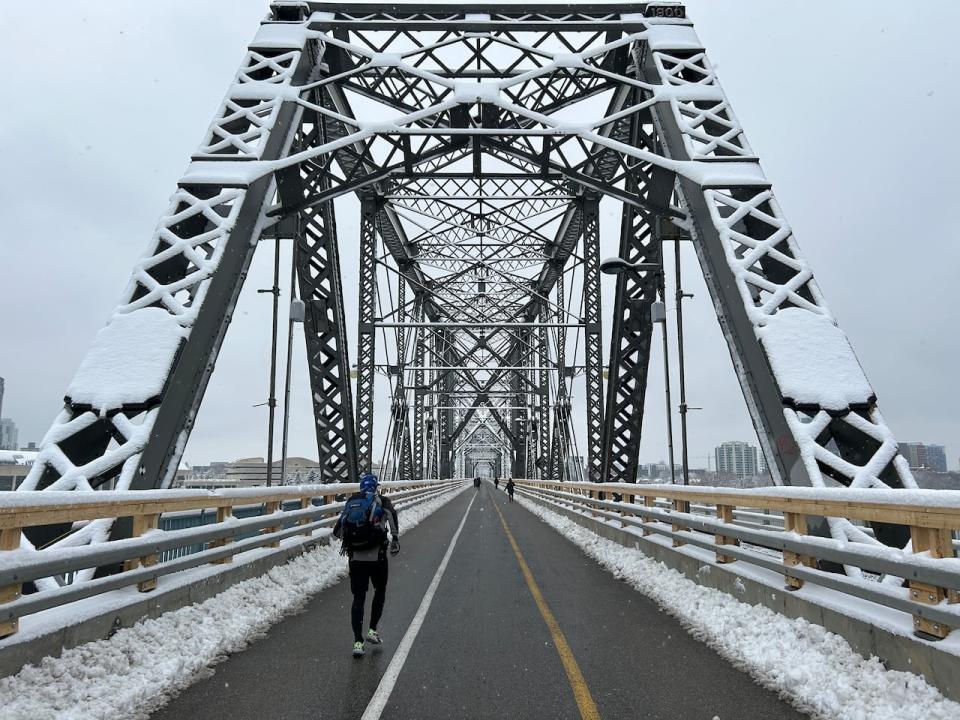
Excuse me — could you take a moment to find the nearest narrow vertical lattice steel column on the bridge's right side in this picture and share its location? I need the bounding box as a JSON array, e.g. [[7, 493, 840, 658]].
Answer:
[[582, 195, 604, 482]]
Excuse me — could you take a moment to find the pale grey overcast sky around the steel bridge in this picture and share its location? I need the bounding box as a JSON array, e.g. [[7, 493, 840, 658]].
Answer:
[[0, 0, 960, 467]]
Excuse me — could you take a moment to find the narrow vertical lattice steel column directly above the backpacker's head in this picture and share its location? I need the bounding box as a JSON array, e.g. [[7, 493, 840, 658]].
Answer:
[[357, 196, 378, 472]]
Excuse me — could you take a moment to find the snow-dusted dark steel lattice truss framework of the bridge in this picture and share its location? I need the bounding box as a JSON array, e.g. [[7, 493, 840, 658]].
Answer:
[[23, 2, 914, 580]]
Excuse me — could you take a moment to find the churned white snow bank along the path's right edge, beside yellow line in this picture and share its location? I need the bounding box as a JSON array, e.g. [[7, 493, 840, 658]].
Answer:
[[517, 495, 960, 720]]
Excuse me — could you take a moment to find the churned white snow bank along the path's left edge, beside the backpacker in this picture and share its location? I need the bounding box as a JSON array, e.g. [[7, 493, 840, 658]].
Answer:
[[0, 485, 467, 720]]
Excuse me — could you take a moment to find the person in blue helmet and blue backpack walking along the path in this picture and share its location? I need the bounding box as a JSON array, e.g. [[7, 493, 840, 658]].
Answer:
[[333, 473, 400, 657]]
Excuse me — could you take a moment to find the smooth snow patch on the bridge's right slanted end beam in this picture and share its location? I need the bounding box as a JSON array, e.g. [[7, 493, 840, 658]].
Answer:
[[757, 308, 874, 410]]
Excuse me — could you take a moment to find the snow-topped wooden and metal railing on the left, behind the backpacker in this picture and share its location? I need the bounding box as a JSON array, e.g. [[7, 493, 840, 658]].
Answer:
[[0, 480, 464, 638]]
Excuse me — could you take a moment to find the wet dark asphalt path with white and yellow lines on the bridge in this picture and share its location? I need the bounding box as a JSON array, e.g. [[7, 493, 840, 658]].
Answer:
[[153, 483, 803, 720]]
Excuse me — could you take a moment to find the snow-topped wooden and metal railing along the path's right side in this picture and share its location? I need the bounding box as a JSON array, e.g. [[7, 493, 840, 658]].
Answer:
[[515, 480, 960, 639]]
